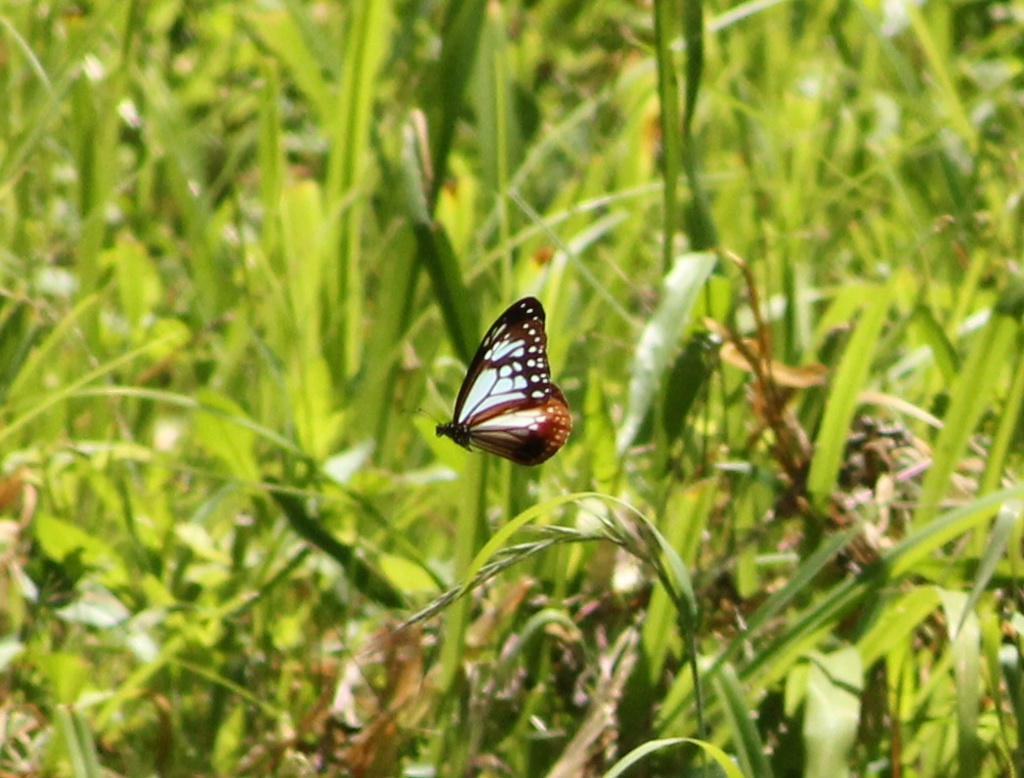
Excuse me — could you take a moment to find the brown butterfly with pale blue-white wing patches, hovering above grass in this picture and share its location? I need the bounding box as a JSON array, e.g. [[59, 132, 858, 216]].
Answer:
[[437, 297, 572, 465]]
